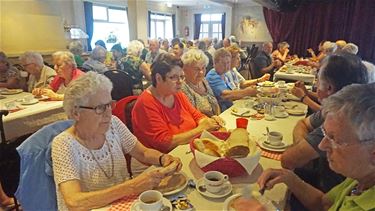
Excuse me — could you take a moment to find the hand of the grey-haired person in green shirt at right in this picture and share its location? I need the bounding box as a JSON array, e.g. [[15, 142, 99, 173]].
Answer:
[[257, 169, 297, 190]]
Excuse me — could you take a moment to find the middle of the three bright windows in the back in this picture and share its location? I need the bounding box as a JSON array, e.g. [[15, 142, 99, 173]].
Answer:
[[149, 13, 173, 39]]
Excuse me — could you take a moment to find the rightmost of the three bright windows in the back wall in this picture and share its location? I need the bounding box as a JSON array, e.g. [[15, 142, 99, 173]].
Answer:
[[199, 14, 223, 40]]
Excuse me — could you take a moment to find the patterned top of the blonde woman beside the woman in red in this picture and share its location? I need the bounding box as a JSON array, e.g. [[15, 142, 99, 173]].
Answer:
[[182, 79, 219, 117]]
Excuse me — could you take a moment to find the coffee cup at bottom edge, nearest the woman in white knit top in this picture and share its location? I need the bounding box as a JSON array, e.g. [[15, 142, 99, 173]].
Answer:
[[139, 190, 163, 211]]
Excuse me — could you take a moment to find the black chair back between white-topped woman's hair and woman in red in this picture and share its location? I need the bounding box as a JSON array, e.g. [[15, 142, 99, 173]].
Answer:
[[104, 70, 133, 101]]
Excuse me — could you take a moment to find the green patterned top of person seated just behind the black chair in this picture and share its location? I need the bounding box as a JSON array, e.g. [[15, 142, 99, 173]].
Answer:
[[119, 55, 144, 95]]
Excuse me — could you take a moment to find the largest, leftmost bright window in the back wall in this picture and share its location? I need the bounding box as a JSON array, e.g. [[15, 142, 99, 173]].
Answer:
[[91, 5, 129, 50]]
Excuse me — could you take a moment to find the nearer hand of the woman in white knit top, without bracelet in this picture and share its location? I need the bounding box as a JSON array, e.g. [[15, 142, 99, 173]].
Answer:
[[131, 169, 164, 193]]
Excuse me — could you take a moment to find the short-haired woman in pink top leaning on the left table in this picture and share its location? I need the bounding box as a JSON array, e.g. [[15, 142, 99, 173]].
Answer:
[[32, 51, 84, 100]]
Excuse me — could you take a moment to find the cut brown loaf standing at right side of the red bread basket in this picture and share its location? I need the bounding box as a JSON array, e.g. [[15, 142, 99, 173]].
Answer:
[[225, 128, 250, 158]]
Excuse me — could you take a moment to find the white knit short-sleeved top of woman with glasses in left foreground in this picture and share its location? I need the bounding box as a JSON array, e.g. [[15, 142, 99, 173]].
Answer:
[[52, 116, 137, 210]]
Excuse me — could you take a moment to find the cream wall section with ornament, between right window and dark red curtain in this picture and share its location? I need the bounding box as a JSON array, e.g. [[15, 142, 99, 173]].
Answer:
[[232, 4, 272, 42]]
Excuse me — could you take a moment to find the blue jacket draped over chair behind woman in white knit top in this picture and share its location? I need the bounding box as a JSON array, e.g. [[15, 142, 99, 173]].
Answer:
[[15, 120, 73, 211]]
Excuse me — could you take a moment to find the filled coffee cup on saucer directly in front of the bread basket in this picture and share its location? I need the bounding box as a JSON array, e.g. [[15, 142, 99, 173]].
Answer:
[[203, 171, 228, 193]]
